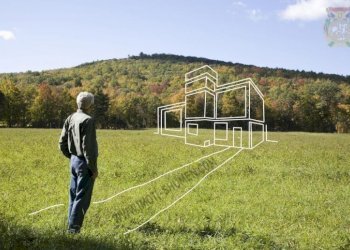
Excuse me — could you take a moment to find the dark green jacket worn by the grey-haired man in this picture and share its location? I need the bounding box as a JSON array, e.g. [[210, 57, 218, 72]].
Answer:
[[59, 109, 98, 173]]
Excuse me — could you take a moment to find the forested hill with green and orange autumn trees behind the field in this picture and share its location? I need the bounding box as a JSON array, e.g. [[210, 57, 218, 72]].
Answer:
[[0, 53, 350, 132]]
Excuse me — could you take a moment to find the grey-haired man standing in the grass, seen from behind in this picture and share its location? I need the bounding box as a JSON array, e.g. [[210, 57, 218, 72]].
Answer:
[[59, 92, 98, 233]]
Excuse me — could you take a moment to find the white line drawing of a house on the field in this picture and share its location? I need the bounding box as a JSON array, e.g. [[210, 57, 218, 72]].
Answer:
[[156, 65, 268, 149]]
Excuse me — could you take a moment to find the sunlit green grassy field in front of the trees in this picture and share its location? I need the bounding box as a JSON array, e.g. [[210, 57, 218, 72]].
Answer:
[[0, 129, 350, 249]]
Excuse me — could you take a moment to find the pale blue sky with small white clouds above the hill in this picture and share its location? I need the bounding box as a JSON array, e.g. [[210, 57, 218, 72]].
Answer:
[[0, 0, 350, 75]]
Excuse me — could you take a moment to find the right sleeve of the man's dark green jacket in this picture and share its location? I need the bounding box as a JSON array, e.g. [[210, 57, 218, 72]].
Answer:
[[82, 118, 98, 173]]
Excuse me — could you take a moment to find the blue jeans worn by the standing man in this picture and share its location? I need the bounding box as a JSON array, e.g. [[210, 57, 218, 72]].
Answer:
[[68, 155, 94, 231]]
